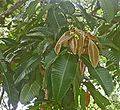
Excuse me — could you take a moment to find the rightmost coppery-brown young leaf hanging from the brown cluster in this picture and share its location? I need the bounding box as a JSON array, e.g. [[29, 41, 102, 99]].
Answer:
[[88, 40, 99, 68]]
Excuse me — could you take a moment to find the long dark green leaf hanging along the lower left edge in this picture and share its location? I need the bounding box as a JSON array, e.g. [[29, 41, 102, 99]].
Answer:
[[0, 51, 18, 107]]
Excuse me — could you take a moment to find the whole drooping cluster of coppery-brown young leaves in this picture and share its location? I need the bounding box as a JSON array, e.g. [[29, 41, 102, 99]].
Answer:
[[54, 28, 99, 69]]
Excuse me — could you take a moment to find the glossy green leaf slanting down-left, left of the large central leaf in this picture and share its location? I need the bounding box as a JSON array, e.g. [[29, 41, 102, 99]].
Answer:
[[15, 55, 41, 84]]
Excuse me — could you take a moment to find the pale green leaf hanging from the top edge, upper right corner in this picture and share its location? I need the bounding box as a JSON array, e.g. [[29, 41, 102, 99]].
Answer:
[[99, 0, 118, 22]]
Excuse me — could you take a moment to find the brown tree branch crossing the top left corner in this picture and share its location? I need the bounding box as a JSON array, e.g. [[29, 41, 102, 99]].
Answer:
[[0, 0, 27, 19]]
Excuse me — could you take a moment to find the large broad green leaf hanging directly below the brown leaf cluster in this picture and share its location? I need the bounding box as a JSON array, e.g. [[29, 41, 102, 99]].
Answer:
[[51, 53, 77, 102]]
